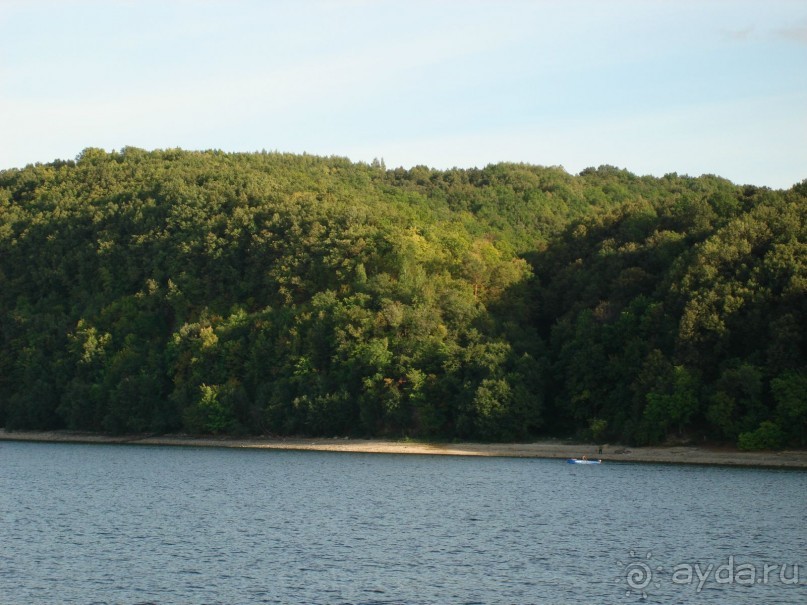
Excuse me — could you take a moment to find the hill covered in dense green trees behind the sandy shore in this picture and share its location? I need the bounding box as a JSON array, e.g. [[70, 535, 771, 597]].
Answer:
[[0, 148, 807, 448]]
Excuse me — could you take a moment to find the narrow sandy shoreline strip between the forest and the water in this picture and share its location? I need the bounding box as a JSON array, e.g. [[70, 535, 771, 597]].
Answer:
[[0, 429, 807, 469]]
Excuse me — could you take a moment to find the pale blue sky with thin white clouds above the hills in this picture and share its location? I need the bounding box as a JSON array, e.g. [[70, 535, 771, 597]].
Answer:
[[0, 0, 807, 189]]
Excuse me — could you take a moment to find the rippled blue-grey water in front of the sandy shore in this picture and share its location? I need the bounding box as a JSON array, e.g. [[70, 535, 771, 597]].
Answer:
[[0, 442, 807, 605]]
